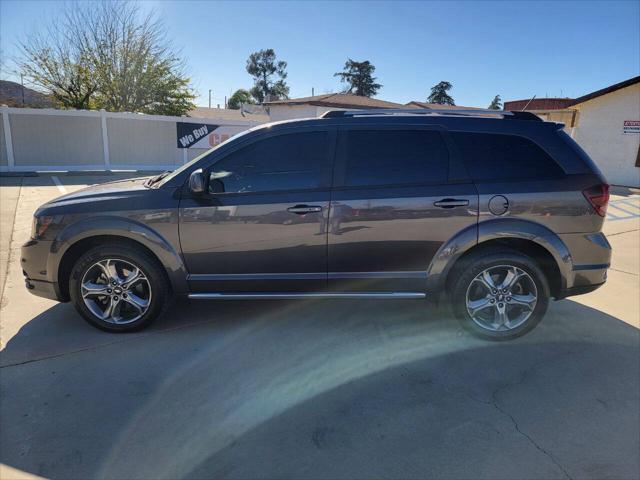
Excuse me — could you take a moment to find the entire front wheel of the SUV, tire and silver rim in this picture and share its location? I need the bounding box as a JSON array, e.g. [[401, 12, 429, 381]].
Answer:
[[69, 244, 171, 333]]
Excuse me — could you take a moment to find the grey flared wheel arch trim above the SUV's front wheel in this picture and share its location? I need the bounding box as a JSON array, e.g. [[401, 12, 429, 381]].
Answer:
[[47, 215, 188, 293]]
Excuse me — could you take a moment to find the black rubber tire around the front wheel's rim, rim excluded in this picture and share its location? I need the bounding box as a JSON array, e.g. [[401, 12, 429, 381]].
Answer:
[[69, 246, 168, 332]]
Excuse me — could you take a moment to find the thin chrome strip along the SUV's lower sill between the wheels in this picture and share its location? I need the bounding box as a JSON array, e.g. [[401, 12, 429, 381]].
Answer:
[[189, 292, 426, 300]]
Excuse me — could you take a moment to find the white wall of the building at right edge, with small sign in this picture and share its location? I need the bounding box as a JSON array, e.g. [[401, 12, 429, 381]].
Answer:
[[573, 84, 640, 187]]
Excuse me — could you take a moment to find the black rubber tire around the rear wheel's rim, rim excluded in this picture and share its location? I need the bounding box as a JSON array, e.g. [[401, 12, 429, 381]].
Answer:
[[451, 252, 550, 341]]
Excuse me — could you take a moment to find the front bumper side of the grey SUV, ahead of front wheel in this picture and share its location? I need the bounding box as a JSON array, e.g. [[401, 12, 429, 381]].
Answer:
[[20, 239, 62, 302]]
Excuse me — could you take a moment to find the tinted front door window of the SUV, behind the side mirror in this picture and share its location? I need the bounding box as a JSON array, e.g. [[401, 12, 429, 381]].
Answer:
[[209, 132, 330, 193]]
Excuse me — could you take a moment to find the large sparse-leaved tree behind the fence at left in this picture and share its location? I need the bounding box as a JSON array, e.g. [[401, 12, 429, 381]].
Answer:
[[19, 1, 195, 115]]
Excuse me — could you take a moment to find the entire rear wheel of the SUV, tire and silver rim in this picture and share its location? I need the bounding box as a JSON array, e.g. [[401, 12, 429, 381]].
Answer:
[[450, 249, 550, 340]]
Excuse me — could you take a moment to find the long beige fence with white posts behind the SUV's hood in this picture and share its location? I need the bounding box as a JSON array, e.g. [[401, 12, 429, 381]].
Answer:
[[0, 107, 258, 172]]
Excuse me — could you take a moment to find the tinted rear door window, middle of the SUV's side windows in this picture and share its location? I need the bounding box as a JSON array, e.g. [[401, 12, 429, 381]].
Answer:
[[345, 130, 449, 186]]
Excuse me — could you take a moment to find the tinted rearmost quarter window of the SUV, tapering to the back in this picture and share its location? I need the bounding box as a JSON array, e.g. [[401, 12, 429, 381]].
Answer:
[[451, 132, 564, 181]]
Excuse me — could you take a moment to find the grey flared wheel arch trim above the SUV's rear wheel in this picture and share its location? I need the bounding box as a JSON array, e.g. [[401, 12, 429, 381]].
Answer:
[[427, 218, 573, 292]]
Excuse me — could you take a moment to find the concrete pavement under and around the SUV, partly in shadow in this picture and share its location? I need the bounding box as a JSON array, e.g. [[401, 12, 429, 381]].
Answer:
[[0, 176, 640, 479]]
